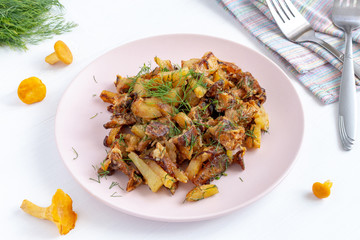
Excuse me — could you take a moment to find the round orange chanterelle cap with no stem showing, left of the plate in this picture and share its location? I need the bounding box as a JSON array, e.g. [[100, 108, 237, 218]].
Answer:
[[17, 77, 46, 104]]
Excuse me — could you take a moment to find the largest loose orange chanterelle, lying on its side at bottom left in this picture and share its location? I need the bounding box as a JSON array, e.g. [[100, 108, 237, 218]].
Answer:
[[21, 189, 77, 235]]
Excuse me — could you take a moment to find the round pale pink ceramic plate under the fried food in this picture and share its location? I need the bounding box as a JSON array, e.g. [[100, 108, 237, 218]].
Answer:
[[56, 34, 304, 222]]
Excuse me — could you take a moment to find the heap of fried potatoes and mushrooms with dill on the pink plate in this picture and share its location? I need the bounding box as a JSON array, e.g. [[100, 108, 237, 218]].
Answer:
[[98, 52, 269, 201]]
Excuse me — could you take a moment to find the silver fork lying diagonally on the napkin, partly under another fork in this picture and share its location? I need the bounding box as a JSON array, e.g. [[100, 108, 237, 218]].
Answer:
[[266, 0, 360, 79]]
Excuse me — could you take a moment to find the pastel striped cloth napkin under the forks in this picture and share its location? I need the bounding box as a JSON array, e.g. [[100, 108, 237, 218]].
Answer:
[[218, 0, 360, 104]]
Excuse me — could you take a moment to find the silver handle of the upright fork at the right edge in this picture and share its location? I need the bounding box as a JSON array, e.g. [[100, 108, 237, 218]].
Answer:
[[339, 32, 357, 144]]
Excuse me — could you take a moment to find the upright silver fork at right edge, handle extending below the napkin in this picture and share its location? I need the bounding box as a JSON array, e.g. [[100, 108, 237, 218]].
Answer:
[[332, 0, 360, 150]]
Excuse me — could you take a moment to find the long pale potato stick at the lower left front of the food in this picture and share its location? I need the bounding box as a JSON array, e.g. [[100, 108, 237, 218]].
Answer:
[[129, 152, 163, 192]]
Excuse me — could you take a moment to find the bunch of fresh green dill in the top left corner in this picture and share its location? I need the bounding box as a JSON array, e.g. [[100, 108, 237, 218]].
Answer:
[[0, 0, 77, 50]]
